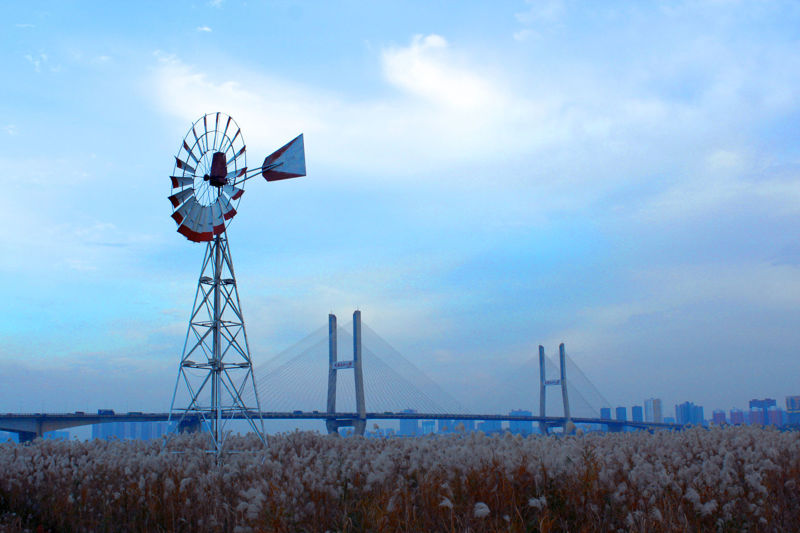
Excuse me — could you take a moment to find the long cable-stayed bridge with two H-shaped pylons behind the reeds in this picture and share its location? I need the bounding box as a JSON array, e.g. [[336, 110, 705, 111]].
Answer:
[[0, 311, 681, 441]]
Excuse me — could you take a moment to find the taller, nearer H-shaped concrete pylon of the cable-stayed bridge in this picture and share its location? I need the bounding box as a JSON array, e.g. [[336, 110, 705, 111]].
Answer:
[[325, 310, 367, 435]]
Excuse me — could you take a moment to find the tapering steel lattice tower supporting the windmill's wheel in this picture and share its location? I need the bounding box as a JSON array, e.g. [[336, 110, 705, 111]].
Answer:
[[170, 232, 267, 455]]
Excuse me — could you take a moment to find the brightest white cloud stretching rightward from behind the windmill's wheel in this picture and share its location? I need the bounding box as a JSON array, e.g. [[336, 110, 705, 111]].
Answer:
[[147, 36, 567, 182]]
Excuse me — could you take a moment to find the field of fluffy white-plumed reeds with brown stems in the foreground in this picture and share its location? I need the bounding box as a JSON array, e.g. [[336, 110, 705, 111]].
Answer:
[[0, 427, 800, 532]]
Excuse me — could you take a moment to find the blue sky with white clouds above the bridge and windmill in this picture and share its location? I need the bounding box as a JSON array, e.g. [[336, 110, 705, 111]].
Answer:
[[0, 0, 800, 411]]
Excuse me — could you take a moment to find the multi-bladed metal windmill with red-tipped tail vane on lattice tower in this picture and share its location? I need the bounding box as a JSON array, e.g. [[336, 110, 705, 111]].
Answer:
[[169, 113, 306, 454]]
